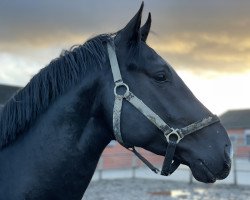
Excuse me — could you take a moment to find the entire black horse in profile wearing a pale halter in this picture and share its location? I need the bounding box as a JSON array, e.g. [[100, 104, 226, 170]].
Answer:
[[0, 3, 231, 200]]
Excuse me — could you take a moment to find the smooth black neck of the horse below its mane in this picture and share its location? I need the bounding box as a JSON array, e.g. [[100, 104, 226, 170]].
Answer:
[[0, 71, 111, 199]]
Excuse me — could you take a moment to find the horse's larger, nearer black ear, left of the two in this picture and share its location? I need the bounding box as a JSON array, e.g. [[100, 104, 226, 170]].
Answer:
[[117, 2, 144, 43]]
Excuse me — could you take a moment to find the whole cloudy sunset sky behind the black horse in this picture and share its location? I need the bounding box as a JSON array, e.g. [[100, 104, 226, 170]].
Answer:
[[0, 0, 250, 114]]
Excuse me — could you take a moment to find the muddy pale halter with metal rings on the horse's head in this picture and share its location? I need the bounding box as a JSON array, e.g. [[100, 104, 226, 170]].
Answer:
[[107, 42, 219, 176]]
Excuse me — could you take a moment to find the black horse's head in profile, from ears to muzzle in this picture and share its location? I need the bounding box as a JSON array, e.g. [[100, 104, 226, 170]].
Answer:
[[100, 5, 231, 183]]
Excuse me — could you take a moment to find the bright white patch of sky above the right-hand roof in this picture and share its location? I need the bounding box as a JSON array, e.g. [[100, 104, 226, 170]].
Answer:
[[179, 70, 250, 114]]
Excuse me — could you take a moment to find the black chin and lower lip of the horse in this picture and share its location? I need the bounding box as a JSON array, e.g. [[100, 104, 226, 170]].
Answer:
[[190, 161, 217, 183]]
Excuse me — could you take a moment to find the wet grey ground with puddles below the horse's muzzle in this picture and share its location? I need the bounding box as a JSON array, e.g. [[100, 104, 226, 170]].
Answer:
[[82, 178, 250, 200]]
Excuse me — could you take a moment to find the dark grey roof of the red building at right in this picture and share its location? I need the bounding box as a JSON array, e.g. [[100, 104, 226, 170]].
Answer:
[[220, 109, 250, 130]]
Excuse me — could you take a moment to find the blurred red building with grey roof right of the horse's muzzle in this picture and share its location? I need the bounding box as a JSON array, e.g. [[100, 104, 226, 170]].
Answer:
[[220, 109, 250, 158]]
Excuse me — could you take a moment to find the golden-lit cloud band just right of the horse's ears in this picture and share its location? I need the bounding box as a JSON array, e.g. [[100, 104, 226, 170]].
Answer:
[[150, 32, 250, 74]]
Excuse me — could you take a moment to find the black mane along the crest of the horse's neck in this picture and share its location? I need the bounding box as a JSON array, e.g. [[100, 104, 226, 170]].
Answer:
[[0, 34, 112, 148]]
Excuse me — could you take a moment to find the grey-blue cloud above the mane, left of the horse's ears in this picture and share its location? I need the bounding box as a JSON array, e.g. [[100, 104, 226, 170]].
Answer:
[[0, 0, 140, 43]]
